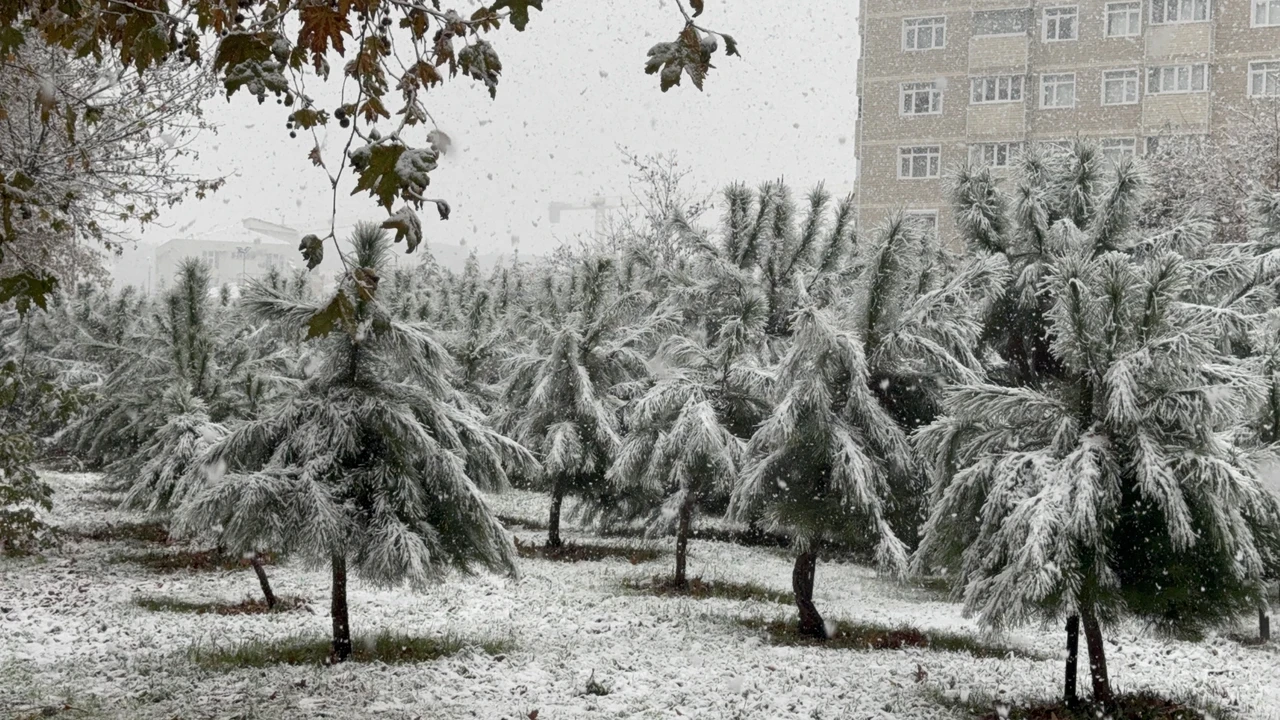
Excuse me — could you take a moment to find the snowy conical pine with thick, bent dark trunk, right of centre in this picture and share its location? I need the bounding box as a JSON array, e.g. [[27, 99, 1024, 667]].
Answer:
[[730, 306, 915, 638]]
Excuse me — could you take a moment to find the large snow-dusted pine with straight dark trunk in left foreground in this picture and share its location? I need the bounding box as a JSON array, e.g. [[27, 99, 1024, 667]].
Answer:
[[179, 225, 532, 661]]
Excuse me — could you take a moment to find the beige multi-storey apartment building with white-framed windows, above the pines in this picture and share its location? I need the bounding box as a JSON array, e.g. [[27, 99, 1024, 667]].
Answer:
[[856, 0, 1280, 237]]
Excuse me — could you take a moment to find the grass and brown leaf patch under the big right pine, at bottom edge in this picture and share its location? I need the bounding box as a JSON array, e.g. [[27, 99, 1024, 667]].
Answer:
[[929, 682, 1223, 720]]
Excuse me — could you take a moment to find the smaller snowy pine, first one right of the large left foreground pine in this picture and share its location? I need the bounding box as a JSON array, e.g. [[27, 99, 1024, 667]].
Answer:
[[502, 256, 664, 547]]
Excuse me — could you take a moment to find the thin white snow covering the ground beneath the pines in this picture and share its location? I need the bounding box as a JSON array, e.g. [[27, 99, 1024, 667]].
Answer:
[[0, 473, 1280, 720]]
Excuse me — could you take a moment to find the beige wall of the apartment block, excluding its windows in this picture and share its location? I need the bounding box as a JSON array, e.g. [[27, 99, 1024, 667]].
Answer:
[[855, 0, 1280, 244]]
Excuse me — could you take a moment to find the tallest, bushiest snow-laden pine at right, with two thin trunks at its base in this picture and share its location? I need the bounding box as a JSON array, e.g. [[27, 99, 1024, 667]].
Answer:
[[915, 145, 1280, 705]]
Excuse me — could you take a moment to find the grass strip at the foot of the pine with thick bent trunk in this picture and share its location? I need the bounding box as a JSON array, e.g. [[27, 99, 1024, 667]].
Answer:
[[739, 619, 1043, 660]]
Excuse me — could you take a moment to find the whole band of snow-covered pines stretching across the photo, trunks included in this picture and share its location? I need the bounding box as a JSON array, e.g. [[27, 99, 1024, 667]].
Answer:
[[0, 141, 1280, 705]]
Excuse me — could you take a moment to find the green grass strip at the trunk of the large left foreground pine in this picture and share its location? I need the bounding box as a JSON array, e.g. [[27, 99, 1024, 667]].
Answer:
[[188, 632, 515, 670]]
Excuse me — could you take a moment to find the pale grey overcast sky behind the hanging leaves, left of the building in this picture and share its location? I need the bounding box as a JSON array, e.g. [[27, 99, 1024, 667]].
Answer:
[[127, 0, 858, 258]]
